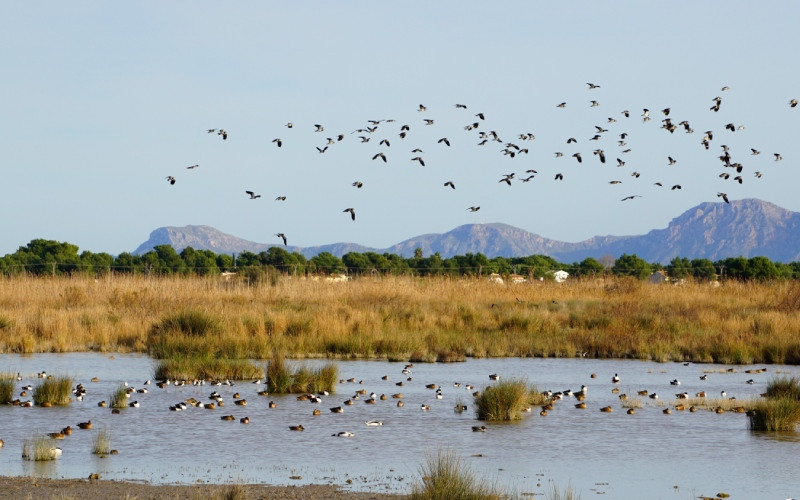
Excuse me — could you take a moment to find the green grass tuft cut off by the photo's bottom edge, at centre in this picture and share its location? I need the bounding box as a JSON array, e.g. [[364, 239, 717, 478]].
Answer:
[[411, 450, 500, 500]]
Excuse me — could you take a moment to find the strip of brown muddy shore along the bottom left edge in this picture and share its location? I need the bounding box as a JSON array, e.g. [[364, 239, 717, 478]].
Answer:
[[0, 476, 405, 500]]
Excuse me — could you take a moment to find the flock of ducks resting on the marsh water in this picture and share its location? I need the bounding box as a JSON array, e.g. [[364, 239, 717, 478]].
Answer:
[[0, 363, 767, 458]]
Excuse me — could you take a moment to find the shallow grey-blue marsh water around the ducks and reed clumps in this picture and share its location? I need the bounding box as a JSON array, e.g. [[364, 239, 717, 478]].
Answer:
[[0, 353, 800, 500]]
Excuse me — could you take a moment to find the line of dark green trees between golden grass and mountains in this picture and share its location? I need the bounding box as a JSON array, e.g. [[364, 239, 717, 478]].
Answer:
[[0, 239, 800, 280]]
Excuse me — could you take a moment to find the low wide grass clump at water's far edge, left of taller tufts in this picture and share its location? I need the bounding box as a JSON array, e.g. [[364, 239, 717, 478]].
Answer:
[[153, 356, 263, 380]]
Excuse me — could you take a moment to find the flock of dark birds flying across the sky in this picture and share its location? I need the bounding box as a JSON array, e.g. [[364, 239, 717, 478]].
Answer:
[[166, 88, 798, 250]]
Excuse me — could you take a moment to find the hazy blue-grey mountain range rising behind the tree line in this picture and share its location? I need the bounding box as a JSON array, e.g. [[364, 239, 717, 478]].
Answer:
[[134, 199, 800, 264]]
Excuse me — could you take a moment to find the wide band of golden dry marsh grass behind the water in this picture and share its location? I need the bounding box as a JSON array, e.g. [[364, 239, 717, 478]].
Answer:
[[0, 276, 800, 364]]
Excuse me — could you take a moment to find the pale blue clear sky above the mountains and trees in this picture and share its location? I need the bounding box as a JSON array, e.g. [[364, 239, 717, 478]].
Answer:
[[0, 0, 800, 255]]
